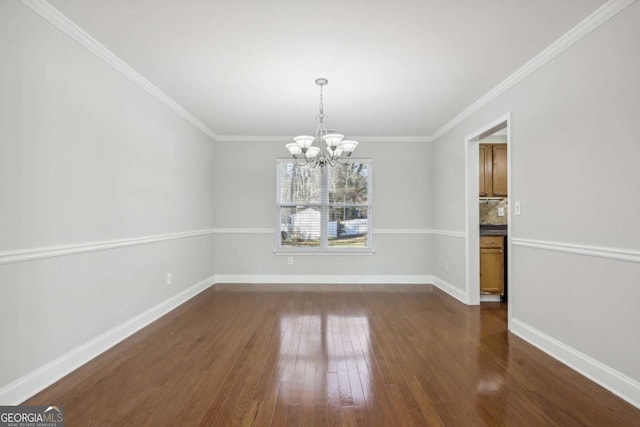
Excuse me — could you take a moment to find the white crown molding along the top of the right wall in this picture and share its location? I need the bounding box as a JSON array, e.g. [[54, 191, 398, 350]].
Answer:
[[429, 0, 635, 141]]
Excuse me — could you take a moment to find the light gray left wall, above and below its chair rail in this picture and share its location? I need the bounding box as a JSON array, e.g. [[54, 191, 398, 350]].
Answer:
[[0, 1, 215, 389]]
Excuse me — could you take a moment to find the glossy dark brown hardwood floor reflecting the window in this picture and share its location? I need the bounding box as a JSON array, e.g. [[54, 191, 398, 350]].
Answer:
[[25, 285, 640, 426]]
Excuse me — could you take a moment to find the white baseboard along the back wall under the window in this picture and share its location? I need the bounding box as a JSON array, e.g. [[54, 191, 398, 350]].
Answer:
[[214, 274, 432, 284]]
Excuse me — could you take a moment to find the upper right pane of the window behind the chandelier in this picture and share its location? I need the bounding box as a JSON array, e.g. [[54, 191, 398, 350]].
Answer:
[[328, 163, 369, 204]]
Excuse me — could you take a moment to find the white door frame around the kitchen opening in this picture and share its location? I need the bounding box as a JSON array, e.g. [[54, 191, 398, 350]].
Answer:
[[464, 113, 513, 320]]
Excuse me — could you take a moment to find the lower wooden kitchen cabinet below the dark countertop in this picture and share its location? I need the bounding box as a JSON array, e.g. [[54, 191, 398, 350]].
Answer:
[[480, 236, 504, 295]]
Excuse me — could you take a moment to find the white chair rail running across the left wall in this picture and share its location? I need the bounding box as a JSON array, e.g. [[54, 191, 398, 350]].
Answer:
[[0, 229, 216, 265]]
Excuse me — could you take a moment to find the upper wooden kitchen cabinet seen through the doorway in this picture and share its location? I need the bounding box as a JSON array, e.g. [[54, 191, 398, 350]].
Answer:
[[478, 144, 507, 197]]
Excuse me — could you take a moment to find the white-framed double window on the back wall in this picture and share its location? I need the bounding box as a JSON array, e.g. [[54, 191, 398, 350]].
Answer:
[[276, 160, 372, 252]]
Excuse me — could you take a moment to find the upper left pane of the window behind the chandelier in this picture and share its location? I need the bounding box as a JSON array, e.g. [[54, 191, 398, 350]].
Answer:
[[279, 162, 322, 204]]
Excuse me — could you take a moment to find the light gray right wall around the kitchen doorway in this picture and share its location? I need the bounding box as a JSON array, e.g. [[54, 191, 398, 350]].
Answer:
[[432, 2, 640, 381]]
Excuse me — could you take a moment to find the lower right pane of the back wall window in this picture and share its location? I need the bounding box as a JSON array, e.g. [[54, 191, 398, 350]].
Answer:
[[327, 206, 369, 248]]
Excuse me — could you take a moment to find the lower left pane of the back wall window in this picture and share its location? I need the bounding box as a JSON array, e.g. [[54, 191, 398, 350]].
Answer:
[[280, 206, 320, 247]]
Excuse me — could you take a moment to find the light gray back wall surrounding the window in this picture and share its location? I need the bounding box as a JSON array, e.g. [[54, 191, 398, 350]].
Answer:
[[215, 142, 432, 281]]
